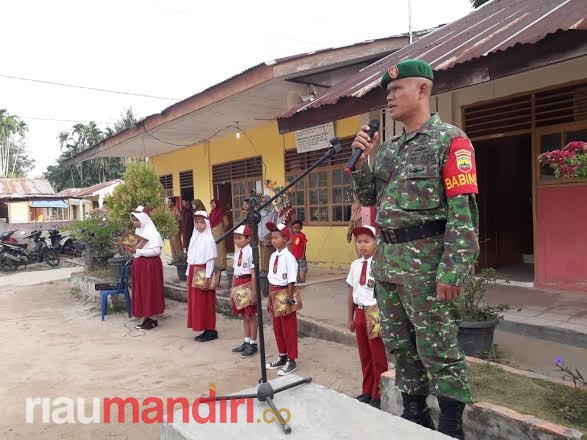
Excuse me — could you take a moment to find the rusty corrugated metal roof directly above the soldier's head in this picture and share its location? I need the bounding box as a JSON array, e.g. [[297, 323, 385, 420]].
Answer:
[[281, 0, 587, 118]]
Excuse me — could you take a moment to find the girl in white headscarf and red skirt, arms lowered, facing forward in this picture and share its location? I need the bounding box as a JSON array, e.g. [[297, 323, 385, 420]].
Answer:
[[186, 211, 218, 342]]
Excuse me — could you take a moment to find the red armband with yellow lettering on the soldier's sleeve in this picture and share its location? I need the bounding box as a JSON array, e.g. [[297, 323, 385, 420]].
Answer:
[[442, 136, 479, 197]]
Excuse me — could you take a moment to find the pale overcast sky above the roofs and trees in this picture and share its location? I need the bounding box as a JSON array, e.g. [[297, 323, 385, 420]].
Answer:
[[0, 0, 472, 177]]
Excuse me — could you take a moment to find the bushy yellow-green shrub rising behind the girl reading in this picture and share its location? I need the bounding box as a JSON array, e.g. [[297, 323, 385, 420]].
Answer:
[[105, 160, 177, 239]]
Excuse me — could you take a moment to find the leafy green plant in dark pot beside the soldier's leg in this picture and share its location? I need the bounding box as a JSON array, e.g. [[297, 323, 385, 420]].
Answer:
[[463, 268, 511, 321]]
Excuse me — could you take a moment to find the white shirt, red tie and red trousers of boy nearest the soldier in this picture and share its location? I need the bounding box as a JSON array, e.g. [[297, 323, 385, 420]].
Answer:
[[346, 257, 388, 400]]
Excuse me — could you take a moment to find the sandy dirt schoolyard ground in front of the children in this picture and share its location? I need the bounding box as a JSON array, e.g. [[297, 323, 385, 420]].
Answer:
[[0, 283, 361, 440]]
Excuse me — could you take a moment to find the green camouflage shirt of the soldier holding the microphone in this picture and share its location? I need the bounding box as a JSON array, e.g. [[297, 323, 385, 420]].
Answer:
[[353, 114, 479, 285]]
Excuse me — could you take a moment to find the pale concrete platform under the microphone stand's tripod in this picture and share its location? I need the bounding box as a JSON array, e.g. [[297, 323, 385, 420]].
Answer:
[[161, 372, 449, 440]]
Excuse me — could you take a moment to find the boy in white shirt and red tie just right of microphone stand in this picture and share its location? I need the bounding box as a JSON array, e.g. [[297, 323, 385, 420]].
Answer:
[[266, 222, 298, 376]]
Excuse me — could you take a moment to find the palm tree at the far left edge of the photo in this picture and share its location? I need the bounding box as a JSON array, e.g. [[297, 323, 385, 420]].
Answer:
[[0, 109, 35, 177]]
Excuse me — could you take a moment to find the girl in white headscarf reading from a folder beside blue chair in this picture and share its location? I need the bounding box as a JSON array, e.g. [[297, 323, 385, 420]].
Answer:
[[126, 206, 165, 330]]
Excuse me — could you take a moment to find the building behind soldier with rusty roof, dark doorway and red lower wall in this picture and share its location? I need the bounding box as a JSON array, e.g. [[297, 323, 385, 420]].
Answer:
[[278, 0, 587, 291]]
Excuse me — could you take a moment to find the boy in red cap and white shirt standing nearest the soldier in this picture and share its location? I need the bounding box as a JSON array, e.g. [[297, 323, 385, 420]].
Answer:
[[346, 226, 388, 408]]
